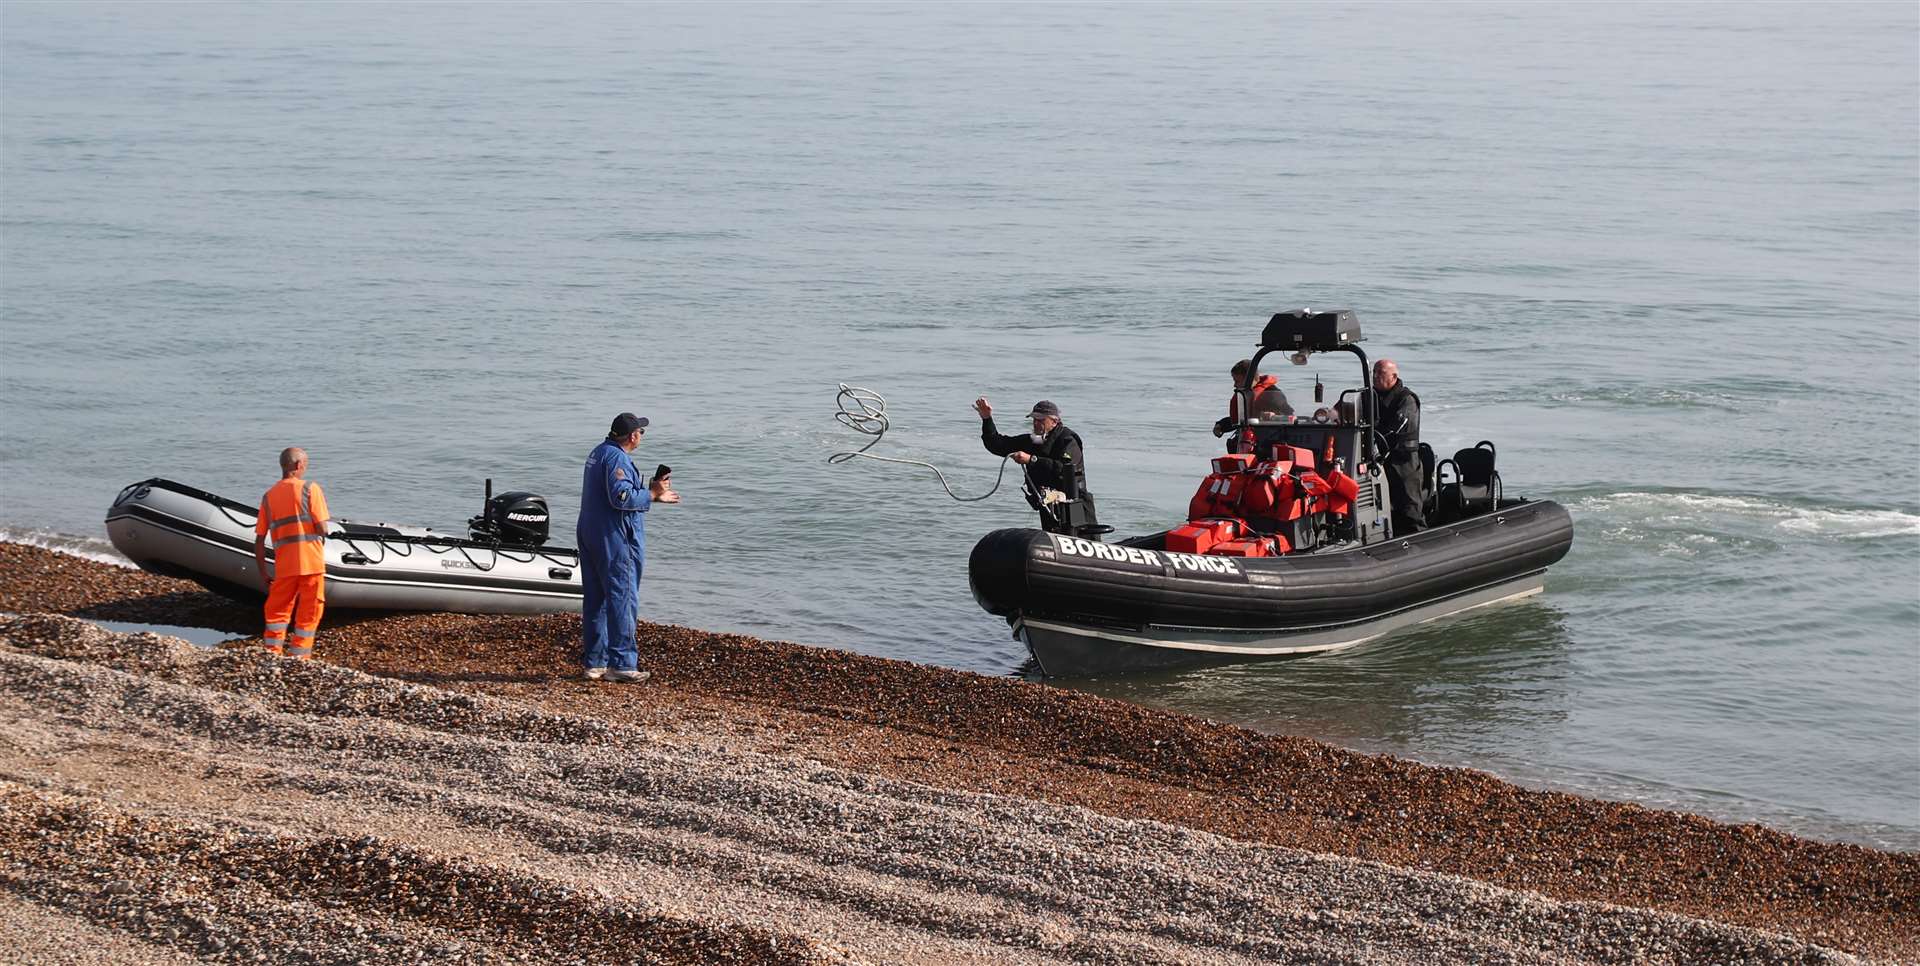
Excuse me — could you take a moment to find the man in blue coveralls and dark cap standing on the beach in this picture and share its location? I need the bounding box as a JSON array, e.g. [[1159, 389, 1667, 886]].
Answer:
[[574, 413, 680, 682]]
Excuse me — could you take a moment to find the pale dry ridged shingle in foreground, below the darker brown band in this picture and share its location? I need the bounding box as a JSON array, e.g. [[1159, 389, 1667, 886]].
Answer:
[[0, 615, 1853, 964]]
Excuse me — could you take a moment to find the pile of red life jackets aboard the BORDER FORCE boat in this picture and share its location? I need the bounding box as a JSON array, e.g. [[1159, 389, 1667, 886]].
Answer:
[[1167, 444, 1359, 557]]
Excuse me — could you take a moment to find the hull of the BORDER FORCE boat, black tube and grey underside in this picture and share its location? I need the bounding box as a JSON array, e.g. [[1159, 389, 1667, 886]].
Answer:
[[968, 501, 1572, 676]]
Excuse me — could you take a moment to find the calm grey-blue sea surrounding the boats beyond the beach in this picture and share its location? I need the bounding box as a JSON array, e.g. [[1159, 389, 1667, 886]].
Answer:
[[0, 2, 1920, 849]]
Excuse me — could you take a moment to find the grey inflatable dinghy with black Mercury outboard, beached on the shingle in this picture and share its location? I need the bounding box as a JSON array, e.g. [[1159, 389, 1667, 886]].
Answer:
[[108, 478, 580, 615]]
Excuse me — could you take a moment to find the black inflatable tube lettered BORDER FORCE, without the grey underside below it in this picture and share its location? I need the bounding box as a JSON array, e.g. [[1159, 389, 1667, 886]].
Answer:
[[968, 501, 1572, 630]]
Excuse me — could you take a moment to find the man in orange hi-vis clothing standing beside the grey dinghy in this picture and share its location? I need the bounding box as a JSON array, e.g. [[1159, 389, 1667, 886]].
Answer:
[[253, 446, 328, 661]]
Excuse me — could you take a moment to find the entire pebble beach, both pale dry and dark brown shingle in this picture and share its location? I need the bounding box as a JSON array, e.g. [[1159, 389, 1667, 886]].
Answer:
[[0, 543, 1920, 962]]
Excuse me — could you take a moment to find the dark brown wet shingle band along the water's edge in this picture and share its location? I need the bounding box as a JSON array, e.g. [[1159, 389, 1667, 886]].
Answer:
[[0, 545, 1920, 960]]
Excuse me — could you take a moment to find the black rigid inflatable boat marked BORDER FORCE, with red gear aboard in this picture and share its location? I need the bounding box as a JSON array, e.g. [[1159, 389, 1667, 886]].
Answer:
[[968, 309, 1572, 676]]
